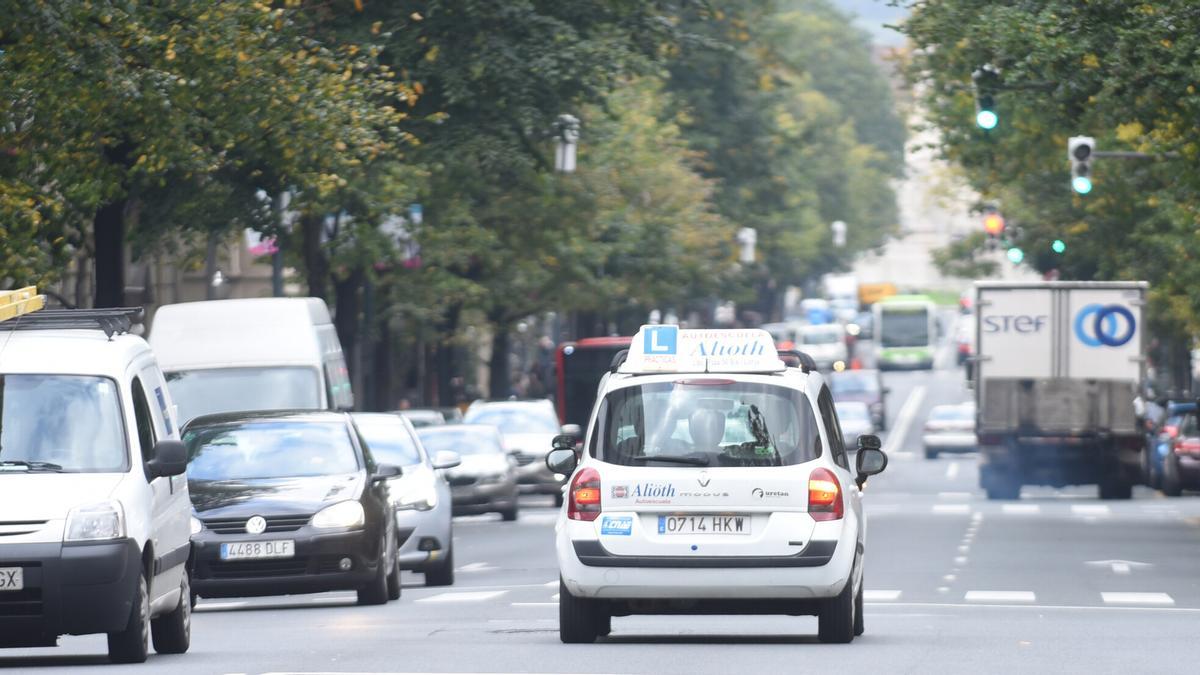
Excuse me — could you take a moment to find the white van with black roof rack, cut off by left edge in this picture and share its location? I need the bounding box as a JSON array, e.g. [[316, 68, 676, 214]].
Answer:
[[0, 300, 192, 663]]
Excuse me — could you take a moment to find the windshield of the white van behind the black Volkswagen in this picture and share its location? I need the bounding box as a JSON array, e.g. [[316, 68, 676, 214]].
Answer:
[[167, 368, 320, 423]]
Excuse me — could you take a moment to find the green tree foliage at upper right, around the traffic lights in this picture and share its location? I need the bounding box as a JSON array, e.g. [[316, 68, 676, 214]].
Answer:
[[905, 0, 1200, 331]]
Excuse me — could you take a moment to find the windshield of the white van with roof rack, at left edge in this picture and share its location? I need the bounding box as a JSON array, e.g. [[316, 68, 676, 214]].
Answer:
[[0, 375, 128, 473]]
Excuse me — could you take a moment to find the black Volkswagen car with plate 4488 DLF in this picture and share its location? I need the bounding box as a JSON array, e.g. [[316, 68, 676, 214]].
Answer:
[[184, 411, 401, 604]]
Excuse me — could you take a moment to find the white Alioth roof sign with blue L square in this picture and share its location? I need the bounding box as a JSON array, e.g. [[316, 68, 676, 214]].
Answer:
[[618, 325, 787, 375]]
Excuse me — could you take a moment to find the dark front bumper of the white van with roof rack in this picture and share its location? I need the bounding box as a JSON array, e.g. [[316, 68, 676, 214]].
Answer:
[[0, 539, 142, 646]]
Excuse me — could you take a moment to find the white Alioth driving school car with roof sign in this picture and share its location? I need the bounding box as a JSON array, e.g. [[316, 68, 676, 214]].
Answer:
[[546, 325, 887, 643]]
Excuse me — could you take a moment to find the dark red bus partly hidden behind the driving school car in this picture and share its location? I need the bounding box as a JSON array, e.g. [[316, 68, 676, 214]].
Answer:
[[556, 336, 634, 425]]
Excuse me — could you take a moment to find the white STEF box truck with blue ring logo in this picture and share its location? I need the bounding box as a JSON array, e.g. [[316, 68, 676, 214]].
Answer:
[[976, 281, 1147, 500]]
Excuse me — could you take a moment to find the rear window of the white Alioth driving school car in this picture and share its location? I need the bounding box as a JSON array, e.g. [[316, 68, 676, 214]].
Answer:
[[590, 380, 821, 467]]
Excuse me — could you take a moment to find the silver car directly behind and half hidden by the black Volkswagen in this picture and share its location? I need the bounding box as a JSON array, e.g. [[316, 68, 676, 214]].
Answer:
[[353, 412, 462, 586]]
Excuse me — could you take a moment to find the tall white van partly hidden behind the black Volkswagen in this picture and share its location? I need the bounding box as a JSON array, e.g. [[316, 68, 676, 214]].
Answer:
[[150, 298, 354, 423]]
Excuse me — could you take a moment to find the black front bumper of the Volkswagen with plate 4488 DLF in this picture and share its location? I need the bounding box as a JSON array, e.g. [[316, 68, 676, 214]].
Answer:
[[192, 530, 382, 598]]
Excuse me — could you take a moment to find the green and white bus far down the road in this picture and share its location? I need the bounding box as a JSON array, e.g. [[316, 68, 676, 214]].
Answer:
[[875, 295, 937, 370]]
